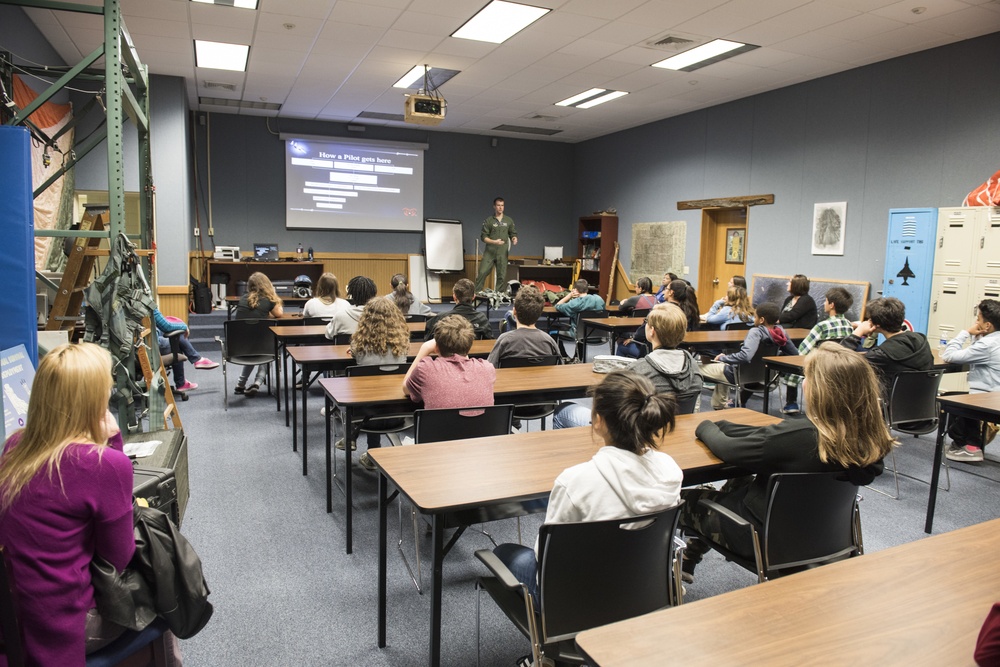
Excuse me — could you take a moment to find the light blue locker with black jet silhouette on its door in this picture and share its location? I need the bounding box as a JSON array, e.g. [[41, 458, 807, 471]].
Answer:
[[882, 208, 937, 333]]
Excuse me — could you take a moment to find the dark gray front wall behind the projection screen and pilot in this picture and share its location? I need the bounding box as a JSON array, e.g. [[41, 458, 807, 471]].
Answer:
[[195, 114, 578, 255]]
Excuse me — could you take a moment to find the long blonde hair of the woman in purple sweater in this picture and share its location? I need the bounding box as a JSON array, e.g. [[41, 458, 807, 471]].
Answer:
[[0, 343, 113, 513]]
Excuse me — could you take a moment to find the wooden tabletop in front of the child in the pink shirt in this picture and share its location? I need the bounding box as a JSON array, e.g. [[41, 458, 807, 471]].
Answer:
[[319, 364, 604, 408]]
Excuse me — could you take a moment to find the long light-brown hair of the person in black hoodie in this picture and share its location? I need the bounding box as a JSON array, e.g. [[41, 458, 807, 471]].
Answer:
[[804, 341, 895, 468]]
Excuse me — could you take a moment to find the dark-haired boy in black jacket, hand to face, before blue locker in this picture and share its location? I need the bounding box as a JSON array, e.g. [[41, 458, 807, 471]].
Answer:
[[841, 296, 934, 397]]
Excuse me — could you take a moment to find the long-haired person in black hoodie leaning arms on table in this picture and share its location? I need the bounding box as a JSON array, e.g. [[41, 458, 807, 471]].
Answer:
[[680, 344, 894, 582]]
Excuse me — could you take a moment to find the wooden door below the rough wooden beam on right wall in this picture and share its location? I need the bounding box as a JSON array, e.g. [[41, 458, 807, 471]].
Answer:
[[698, 206, 749, 312]]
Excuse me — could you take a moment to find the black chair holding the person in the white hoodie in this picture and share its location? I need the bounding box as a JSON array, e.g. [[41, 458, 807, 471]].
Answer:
[[476, 506, 683, 665]]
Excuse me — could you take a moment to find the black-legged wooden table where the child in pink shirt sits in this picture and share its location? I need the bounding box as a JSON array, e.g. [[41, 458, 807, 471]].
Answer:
[[320, 364, 604, 553]]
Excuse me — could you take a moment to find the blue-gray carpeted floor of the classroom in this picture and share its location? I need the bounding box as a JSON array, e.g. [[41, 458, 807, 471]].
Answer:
[[166, 310, 1000, 667]]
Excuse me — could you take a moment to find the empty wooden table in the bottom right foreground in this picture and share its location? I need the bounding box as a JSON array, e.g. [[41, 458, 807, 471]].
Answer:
[[576, 519, 1000, 667]]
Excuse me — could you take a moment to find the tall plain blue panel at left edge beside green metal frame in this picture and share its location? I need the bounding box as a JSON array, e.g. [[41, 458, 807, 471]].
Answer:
[[0, 126, 38, 368]]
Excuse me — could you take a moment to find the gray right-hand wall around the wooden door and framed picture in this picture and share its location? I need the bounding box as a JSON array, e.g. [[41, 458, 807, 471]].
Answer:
[[573, 33, 1000, 290]]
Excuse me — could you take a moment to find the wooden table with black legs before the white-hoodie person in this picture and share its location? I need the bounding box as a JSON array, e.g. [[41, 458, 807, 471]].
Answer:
[[370, 408, 779, 665]]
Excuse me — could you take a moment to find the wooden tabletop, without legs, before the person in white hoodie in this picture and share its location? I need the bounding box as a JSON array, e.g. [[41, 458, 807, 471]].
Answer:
[[369, 408, 781, 514]]
